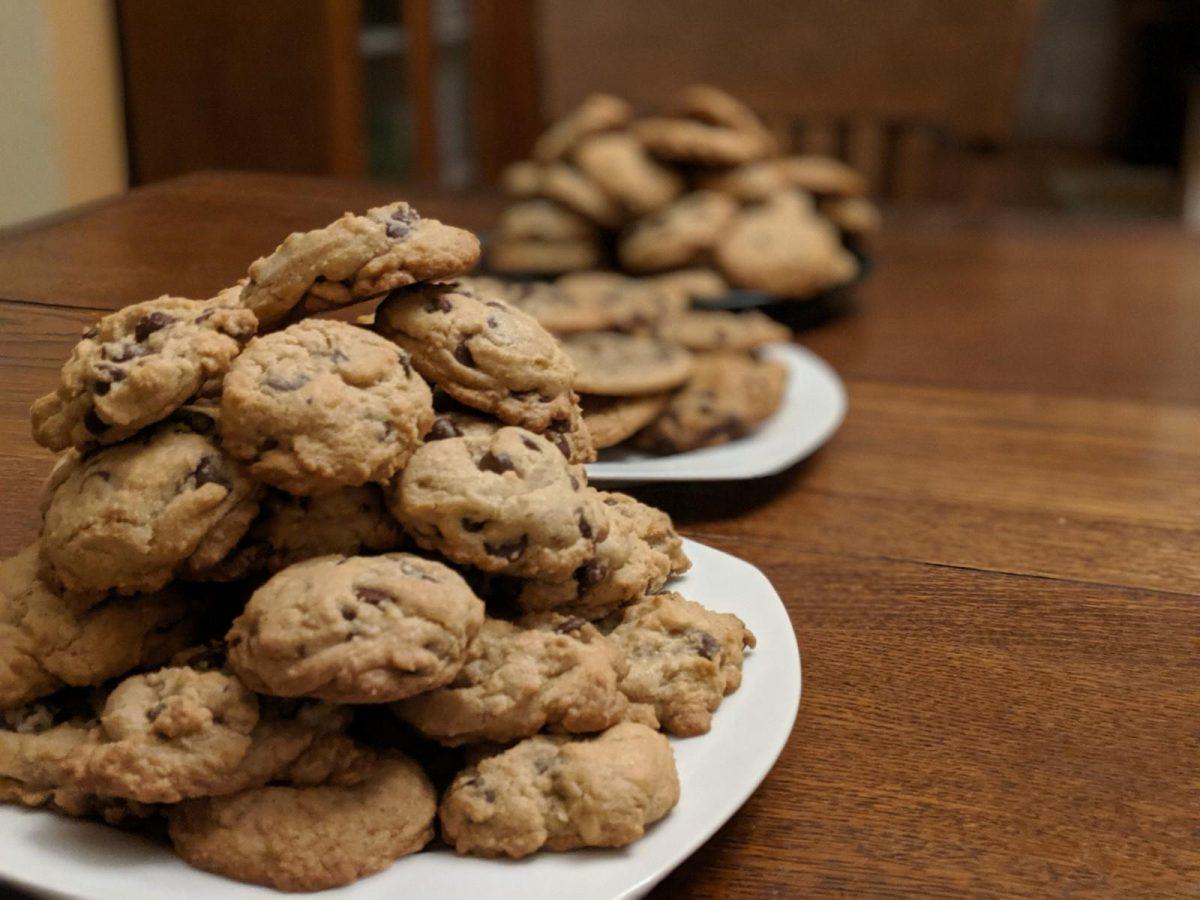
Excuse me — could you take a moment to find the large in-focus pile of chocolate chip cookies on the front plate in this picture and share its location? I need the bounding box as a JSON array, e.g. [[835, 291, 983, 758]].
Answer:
[[0, 203, 755, 890]]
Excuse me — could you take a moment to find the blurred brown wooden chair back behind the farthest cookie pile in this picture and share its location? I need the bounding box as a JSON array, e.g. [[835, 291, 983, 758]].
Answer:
[[474, 0, 1038, 200]]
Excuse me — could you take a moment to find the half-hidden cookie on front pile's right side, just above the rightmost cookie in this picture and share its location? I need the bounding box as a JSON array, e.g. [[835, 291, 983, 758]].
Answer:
[[517, 492, 691, 619]]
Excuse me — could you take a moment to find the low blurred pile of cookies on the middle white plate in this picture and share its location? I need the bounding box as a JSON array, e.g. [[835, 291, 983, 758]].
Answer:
[[466, 269, 792, 454]]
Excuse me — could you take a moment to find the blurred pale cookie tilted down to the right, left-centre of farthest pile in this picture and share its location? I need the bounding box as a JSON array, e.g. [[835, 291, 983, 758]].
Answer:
[[575, 132, 684, 216]]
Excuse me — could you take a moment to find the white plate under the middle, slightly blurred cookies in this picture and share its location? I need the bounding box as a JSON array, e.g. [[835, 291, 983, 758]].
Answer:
[[588, 343, 846, 484]]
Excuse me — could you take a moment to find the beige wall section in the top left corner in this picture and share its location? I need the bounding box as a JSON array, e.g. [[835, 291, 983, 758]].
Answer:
[[0, 0, 127, 226]]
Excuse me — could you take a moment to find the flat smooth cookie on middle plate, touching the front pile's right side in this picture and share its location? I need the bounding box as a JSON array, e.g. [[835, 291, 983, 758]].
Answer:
[[562, 331, 691, 397]]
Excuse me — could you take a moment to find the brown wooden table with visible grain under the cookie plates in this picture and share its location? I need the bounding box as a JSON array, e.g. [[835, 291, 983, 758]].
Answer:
[[0, 174, 1200, 898]]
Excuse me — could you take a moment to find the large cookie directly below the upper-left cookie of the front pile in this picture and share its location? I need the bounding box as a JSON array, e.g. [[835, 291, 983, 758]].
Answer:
[[42, 416, 260, 599]]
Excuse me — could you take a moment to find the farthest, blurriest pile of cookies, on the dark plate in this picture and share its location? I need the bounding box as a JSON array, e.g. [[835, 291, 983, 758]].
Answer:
[[488, 84, 880, 298]]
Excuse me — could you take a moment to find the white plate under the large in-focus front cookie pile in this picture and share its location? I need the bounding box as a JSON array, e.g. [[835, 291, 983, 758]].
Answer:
[[0, 541, 800, 900]]
